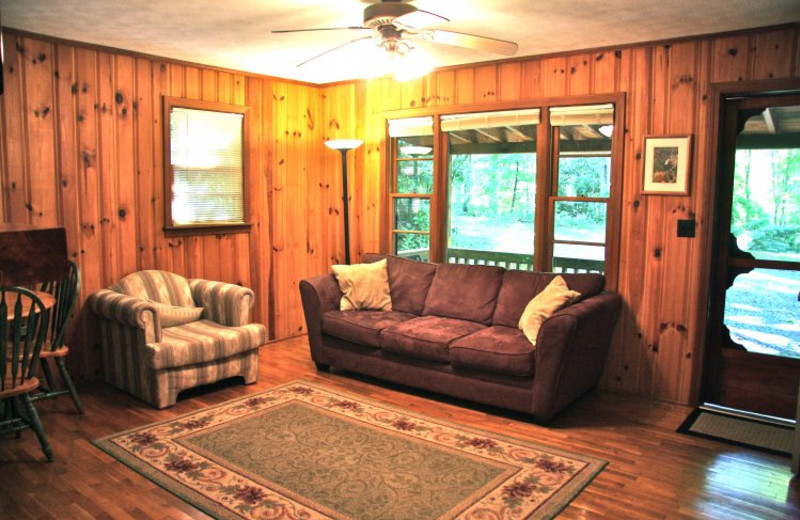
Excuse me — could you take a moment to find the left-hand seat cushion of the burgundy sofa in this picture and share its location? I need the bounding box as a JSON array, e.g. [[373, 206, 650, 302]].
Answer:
[[322, 311, 416, 348]]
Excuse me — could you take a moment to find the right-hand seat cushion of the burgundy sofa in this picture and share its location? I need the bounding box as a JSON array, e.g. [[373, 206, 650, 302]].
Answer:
[[450, 327, 534, 377]]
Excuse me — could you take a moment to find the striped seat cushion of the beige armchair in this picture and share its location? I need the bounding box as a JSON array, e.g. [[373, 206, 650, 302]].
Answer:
[[143, 320, 267, 370]]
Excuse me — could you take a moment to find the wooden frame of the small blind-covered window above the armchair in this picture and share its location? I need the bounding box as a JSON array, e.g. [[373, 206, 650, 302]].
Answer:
[[162, 96, 252, 237]]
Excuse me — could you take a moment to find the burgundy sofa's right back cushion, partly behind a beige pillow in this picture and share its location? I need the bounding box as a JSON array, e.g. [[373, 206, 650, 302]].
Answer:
[[492, 269, 606, 327]]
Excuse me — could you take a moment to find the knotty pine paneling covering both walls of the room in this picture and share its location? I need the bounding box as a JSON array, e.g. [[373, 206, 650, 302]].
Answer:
[[0, 24, 800, 403]]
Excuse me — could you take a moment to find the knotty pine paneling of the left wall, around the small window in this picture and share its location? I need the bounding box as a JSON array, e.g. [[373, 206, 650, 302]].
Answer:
[[0, 30, 332, 382]]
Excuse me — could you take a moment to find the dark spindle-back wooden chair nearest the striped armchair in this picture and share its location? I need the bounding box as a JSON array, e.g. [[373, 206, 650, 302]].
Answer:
[[33, 261, 83, 414]]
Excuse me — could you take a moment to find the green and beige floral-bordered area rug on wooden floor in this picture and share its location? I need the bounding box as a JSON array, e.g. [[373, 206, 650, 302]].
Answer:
[[94, 381, 606, 520]]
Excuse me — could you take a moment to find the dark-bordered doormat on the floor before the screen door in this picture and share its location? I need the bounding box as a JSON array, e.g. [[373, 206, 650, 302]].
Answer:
[[678, 407, 794, 456]]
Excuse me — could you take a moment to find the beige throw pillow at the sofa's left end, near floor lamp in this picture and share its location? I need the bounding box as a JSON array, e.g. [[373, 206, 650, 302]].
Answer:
[[332, 258, 392, 311]]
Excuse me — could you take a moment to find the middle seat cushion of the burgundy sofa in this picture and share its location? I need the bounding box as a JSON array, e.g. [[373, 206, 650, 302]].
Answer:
[[381, 316, 484, 363]]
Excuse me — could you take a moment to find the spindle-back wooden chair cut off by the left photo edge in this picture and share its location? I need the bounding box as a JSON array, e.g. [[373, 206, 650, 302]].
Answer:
[[0, 287, 53, 462]]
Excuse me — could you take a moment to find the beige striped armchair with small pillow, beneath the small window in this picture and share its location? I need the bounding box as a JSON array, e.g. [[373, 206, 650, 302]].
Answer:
[[87, 270, 267, 408]]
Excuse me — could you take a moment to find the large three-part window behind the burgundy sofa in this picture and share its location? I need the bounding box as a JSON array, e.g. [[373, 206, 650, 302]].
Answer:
[[389, 104, 614, 273]]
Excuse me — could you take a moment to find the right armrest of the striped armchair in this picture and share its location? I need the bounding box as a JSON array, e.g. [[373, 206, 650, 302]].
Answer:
[[189, 278, 255, 327]]
